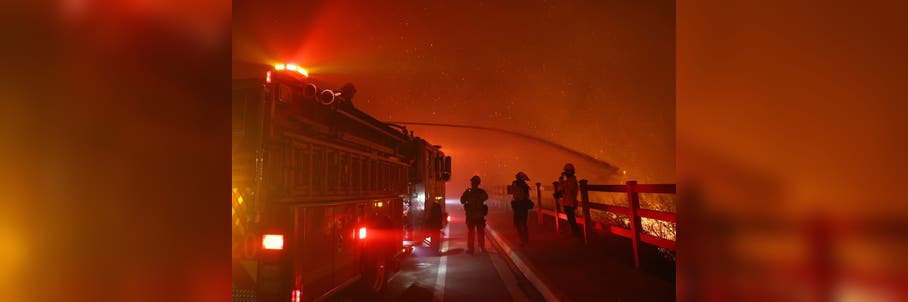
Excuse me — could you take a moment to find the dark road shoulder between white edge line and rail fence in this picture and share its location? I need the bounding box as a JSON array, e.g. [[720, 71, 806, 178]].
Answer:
[[486, 200, 675, 301]]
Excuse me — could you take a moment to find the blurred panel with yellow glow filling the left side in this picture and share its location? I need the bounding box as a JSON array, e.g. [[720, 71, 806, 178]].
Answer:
[[0, 0, 230, 301]]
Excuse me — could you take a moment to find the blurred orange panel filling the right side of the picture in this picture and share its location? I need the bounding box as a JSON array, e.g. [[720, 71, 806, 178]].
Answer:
[[677, 0, 908, 301]]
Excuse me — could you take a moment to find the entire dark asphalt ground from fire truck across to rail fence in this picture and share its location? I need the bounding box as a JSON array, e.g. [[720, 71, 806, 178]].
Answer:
[[333, 195, 675, 302]]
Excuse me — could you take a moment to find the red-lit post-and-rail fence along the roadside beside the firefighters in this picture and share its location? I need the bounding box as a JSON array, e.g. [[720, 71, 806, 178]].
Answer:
[[536, 179, 677, 268]]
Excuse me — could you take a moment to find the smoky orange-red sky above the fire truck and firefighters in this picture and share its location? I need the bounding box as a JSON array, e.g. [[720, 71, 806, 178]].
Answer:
[[233, 1, 675, 183]]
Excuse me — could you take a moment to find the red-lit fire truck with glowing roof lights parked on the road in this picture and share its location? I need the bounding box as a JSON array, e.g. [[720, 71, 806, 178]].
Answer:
[[231, 64, 451, 302]]
